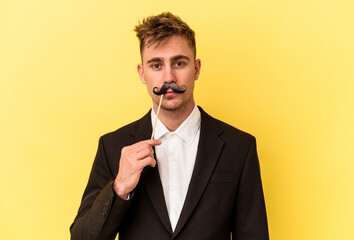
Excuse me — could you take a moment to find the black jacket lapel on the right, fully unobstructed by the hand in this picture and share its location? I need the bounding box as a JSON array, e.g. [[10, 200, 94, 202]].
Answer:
[[173, 108, 224, 238]]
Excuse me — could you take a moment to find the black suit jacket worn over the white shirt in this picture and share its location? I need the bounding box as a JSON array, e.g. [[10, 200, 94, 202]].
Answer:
[[70, 108, 269, 240]]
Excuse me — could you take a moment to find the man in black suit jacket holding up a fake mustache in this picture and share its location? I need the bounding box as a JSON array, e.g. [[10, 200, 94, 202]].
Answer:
[[70, 13, 269, 240]]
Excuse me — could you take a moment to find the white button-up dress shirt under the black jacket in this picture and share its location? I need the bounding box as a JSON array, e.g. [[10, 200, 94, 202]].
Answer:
[[151, 105, 200, 231]]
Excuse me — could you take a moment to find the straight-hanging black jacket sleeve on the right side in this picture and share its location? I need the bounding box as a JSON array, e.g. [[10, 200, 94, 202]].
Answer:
[[232, 138, 269, 240]]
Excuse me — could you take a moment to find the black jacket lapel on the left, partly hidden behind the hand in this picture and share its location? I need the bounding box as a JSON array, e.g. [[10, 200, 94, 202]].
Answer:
[[131, 111, 172, 235]]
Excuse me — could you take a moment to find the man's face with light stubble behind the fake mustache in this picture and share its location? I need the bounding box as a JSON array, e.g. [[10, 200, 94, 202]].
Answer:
[[138, 36, 200, 111]]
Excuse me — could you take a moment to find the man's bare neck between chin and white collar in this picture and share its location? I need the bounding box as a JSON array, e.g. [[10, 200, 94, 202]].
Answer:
[[154, 101, 195, 132]]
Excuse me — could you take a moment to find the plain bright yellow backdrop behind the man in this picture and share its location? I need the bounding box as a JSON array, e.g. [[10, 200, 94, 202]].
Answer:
[[0, 0, 354, 240]]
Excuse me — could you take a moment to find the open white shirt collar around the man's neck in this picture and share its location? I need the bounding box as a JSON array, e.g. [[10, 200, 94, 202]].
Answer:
[[151, 105, 200, 143]]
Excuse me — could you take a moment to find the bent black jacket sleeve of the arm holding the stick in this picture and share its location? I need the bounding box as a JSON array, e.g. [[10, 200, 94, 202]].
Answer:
[[70, 138, 130, 240]]
